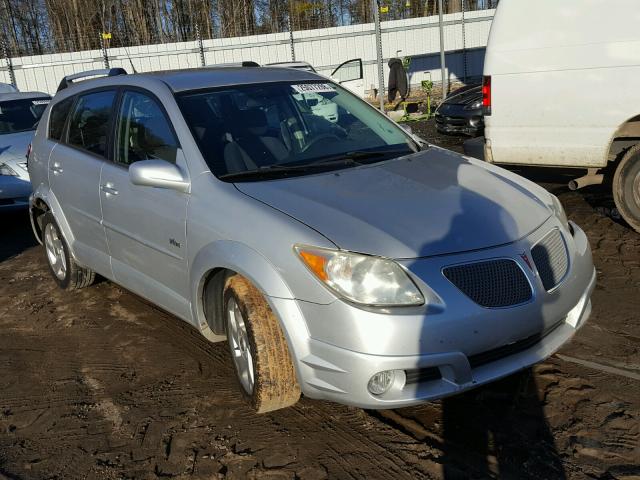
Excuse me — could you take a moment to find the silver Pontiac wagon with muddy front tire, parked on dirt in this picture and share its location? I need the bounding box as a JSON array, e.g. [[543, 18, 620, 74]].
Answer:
[[28, 67, 596, 412]]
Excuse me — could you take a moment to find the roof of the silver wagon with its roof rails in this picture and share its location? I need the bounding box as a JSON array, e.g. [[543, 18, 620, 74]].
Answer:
[[60, 66, 327, 98]]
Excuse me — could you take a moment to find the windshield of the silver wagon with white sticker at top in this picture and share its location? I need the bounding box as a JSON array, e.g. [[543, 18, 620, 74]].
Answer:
[[178, 82, 417, 181]]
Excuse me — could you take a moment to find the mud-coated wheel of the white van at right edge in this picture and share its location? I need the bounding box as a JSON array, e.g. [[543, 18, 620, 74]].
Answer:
[[613, 145, 640, 232]]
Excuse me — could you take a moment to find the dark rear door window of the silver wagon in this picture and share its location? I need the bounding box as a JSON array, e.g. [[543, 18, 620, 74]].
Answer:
[[67, 91, 116, 157]]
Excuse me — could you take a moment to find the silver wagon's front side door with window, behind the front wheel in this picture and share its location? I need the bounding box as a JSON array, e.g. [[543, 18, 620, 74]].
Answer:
[[100, 90, 190, 320]]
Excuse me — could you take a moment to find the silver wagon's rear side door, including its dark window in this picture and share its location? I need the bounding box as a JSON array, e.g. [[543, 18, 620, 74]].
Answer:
[[49, 89, 116, 276]]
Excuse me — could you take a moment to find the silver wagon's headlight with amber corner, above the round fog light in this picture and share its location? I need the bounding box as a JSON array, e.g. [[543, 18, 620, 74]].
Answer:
[[295, 245, 424, 307]]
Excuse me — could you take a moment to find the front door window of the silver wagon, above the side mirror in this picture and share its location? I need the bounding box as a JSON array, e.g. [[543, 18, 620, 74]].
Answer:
[[115, 92, 178, 165]]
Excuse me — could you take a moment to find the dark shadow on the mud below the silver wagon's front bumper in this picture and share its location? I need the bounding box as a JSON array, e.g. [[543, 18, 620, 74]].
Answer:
[[442, 369, 566, 480]]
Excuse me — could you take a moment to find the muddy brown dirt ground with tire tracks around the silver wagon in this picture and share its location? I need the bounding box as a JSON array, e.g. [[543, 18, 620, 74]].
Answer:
[[0, 123, 640, 480]]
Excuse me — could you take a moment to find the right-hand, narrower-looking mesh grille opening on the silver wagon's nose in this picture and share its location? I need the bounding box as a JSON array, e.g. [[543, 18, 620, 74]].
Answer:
[[531, 229, 569, 290]]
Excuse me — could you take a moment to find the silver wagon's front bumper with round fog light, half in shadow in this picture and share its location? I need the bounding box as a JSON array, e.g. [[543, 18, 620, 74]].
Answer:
[[271, 219, 596, 409]]
